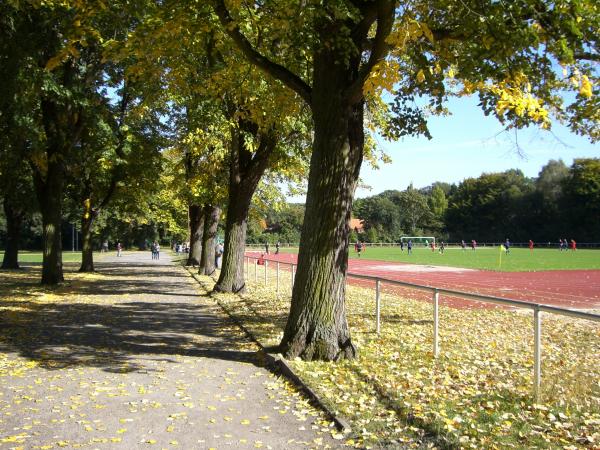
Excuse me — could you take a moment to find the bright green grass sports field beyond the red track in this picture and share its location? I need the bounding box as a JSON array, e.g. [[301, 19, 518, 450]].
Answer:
[[282, 247, 600, 272]]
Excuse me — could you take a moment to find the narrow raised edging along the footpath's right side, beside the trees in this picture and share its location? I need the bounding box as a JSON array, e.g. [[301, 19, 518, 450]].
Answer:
[[182, 266, 352, 433]]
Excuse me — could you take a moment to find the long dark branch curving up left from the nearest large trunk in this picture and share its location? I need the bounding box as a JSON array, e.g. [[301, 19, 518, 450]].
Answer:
[[213, 0, 312, 105]]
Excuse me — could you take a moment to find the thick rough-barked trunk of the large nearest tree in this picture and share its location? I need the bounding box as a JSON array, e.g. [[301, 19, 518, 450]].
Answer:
[[280, 52, 364, 360]]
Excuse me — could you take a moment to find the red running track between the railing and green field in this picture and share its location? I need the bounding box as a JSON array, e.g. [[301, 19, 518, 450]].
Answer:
[[246, 252, 600, 309]]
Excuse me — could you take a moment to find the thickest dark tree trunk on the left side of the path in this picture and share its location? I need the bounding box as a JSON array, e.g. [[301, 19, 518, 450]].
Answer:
[[36, 155, 64, 285]]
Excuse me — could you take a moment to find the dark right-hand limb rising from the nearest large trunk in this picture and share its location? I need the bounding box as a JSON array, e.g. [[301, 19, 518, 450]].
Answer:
[[346, 0, 396, 103]]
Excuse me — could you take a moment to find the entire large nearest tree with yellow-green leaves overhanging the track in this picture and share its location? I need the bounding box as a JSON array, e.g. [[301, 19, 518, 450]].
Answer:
[[213, 0, 598, 360]]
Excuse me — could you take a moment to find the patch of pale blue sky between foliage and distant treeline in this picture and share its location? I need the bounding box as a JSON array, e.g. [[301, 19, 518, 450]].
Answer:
[[356, 98, 600, 197]]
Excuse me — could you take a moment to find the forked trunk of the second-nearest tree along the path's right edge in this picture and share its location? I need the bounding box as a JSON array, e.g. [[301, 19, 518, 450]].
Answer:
[[214, 121, 276, 292]]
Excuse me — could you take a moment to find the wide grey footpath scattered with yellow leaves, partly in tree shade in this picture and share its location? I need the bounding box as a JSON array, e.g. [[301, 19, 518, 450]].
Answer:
[[0, 252, 340, 449]]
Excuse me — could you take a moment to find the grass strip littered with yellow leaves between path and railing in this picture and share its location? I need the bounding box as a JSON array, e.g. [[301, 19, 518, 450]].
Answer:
[[197, 266, 600, 449]]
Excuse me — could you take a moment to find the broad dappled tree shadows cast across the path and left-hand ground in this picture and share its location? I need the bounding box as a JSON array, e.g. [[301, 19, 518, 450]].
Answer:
[[0, 264, 261, 372]]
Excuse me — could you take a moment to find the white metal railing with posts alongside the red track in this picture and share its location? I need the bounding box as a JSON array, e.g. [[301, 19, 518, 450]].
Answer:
[[246, 256, 600, 400]]
